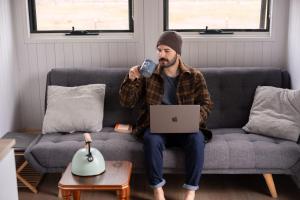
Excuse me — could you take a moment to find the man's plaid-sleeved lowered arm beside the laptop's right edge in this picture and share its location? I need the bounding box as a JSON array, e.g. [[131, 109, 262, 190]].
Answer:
[[195, 72, 213, 126]]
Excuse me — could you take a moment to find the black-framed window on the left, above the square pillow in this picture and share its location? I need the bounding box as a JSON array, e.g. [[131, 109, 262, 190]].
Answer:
[[28, 0, 133, 33]]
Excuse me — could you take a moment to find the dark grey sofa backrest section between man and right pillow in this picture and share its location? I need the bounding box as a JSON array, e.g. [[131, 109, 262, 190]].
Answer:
[[202, 68, 290, 128]]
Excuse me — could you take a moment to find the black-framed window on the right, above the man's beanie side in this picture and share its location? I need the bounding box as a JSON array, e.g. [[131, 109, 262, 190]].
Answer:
[[164, 0, 270, 32]]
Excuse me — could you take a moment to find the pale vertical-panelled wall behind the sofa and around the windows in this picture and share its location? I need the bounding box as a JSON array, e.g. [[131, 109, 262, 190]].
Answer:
[[13, 0, 289, 128]]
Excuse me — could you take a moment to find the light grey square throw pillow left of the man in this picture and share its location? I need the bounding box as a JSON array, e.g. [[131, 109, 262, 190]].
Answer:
[[43, 84, 105, 133]]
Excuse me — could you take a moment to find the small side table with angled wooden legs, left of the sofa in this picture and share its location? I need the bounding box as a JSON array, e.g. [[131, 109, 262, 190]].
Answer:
[[3, 132, 43, 193]]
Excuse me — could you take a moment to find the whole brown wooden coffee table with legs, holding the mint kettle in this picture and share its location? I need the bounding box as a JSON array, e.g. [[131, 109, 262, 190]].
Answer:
[[58, 161, 132, 200]]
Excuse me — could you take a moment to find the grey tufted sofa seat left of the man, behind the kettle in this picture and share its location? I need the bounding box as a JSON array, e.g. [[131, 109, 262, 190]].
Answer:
[[28, 128, 143, 172]]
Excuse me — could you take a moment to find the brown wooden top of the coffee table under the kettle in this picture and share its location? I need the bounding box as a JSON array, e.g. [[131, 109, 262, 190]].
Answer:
[[58, 161, 132, 190]]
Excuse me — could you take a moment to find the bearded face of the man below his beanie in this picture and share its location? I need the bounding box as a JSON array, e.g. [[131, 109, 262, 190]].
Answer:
[[157, 45, 177, 68]]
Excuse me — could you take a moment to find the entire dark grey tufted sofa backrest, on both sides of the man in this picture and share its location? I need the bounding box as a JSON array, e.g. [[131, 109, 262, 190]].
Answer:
[[45, 68, 290, 128]]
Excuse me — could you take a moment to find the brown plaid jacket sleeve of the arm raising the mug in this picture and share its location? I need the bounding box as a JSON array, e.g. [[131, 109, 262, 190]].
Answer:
[[119, 74, 145, 108]]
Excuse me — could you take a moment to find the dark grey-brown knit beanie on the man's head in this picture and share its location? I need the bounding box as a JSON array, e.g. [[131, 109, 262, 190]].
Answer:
[[156, 31, 182, 55]]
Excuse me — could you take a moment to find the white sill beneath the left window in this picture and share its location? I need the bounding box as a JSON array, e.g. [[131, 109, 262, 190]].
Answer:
[[25, 33, 137, 43]]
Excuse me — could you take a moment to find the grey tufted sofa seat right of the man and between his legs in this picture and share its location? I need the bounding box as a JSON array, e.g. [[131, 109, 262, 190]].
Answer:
[[164, 128, 300, 171]]
